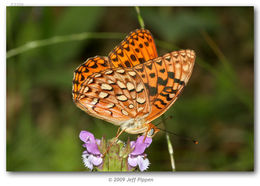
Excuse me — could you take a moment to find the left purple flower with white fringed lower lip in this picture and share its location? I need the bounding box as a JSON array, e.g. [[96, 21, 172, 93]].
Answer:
[[79, 131, 103, 170]]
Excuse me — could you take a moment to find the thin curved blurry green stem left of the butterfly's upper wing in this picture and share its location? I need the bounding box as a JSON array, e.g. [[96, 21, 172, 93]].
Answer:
[[6, 32, 125, 59]]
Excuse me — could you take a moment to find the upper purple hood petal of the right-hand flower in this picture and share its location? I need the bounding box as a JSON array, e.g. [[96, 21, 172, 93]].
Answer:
[[131, 136, 152, 155]]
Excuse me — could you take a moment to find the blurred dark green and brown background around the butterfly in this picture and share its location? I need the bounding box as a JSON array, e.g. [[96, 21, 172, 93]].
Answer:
[[6, 7, 254, 171]]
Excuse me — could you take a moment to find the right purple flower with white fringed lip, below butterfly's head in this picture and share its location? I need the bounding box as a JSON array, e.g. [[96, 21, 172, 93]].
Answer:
[[128, 136, 152, 171]]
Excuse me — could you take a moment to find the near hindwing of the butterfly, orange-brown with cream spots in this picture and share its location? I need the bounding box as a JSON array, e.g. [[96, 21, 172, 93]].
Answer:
[[73, 67, 151, 125]]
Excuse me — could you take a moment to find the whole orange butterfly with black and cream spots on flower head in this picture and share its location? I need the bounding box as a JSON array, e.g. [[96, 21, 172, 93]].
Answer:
[[72, 29, 195, 137]]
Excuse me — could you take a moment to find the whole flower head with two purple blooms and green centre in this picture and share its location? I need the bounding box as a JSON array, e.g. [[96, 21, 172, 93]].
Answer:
[[79, 131, 152, 171]]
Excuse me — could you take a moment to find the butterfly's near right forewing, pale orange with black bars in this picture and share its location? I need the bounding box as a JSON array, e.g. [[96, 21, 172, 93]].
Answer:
[[139, 50, 196, 123]]
